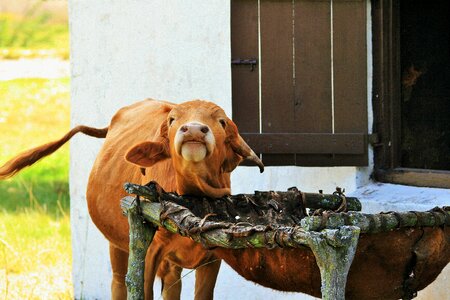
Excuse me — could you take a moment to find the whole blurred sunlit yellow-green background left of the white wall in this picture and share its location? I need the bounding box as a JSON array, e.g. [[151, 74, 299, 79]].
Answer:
[[0, 0, 73, 299]]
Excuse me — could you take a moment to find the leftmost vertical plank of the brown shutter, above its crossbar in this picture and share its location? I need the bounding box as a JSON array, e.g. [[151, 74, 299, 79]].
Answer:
[[231, 0, 259, 132]]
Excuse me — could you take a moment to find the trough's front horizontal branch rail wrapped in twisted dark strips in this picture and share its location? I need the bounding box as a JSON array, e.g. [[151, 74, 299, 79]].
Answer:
[[121, 197, 359, 249]]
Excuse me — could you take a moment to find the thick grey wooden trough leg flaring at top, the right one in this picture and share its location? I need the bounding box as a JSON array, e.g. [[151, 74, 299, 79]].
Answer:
[[309, 226, 360, 300]]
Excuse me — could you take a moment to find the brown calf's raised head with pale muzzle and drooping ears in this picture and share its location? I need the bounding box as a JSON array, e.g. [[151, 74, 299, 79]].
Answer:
[[126, 100, 264, 197]]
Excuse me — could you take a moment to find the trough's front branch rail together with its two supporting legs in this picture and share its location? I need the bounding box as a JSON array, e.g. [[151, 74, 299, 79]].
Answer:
[[121, 197, 360, 300]]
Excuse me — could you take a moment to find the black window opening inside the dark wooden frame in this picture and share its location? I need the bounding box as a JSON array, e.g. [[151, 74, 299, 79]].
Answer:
[[400, 0, 450, 170]]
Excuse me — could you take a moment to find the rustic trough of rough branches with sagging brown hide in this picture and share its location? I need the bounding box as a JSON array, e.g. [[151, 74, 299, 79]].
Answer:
[[121, 182, 450, 299]]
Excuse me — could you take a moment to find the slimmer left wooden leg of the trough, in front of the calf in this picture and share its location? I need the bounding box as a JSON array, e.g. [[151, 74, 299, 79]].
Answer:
[[125, 201, 156, 300]]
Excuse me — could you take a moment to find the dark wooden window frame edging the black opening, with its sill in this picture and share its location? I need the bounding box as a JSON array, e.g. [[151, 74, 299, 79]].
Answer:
[[372, 0, 450, 188]]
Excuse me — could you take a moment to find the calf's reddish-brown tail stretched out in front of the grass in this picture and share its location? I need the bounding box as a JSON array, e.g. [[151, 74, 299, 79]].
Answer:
[[0, 125, 108, 180]]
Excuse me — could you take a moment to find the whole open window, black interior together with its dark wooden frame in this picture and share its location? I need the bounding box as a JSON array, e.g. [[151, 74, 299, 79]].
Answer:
[[372, 0, 450, 188]]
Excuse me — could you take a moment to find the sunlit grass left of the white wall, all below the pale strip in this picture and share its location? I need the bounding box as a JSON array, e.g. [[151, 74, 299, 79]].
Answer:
[[0, 78, 73, 299]]
